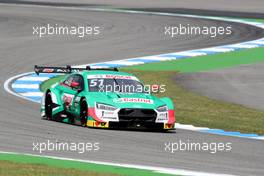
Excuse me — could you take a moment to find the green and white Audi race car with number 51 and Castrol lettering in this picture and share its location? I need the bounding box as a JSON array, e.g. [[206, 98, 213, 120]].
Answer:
[[34, 65, 175, 131]]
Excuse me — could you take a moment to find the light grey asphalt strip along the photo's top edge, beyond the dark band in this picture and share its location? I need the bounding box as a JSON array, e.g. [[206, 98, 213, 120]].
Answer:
[[5, 0, 264, 15]]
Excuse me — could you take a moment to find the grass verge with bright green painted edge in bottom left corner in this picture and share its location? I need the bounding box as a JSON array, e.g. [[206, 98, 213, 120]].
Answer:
[[0, 153, 178, 176]]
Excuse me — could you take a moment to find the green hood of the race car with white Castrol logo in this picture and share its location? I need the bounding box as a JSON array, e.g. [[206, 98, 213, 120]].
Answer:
[[86, 92, 165, 109]]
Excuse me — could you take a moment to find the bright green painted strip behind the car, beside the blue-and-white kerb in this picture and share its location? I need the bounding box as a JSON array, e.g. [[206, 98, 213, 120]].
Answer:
[[122, 47, 264, 72]]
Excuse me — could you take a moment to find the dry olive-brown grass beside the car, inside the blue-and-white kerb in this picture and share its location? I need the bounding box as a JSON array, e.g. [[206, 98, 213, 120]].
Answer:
[[41, 70, 264, 134]]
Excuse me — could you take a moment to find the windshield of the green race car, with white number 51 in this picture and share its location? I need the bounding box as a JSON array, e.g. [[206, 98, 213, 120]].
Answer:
[[88, 78, 146, 93]]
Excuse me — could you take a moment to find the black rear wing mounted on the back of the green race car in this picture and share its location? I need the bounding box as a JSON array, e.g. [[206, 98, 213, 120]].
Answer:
[[34, 65, 118, 75]]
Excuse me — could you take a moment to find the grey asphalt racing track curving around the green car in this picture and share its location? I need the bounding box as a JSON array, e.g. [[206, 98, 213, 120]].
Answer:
[[0, 1, 264, 175]]
